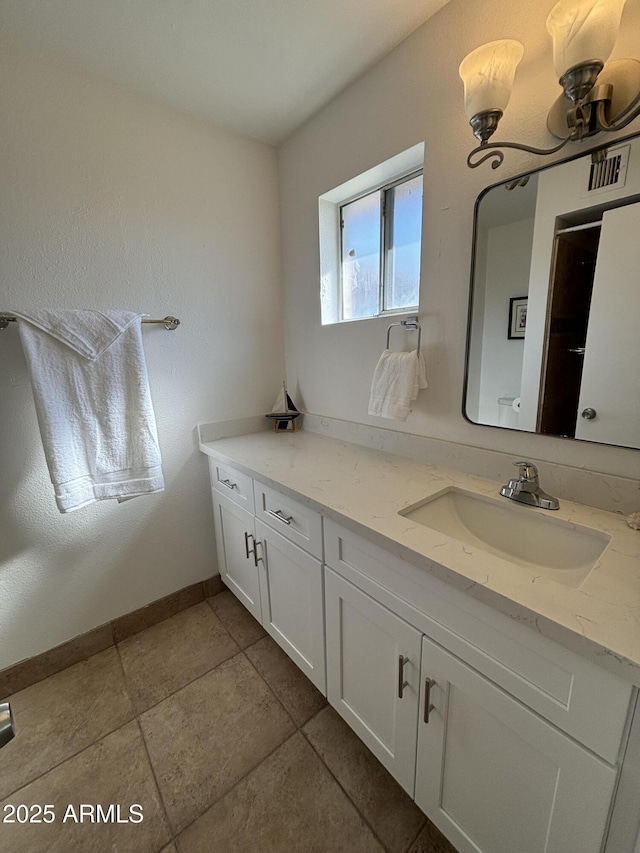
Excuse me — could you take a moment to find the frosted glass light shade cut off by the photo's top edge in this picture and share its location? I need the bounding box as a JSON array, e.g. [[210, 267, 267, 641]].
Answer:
[[547, 0, 626, 79]]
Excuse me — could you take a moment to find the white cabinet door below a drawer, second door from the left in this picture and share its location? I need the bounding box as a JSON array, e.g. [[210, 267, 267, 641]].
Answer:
[[256, 519, 326, 695]]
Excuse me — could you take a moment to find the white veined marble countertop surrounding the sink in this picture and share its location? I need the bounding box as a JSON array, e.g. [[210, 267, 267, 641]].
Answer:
[[200, 430, 640, 686]]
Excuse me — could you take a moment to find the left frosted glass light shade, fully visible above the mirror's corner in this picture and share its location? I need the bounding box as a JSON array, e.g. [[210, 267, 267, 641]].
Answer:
[[458, 39, 524, 119]]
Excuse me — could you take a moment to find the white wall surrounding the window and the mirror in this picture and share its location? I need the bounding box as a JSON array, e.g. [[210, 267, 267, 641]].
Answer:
[[279, 0, 640, 476]]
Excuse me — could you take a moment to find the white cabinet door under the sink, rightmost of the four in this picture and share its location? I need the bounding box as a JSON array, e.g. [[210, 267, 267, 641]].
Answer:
[[415, 638, 616, 853]]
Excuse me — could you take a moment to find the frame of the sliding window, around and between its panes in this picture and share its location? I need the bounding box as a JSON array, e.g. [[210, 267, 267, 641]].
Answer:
[[337, 166, 424, 322]]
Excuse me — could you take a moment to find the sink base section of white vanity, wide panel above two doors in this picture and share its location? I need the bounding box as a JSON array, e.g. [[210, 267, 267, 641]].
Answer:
[[325, 522, 632, 853]]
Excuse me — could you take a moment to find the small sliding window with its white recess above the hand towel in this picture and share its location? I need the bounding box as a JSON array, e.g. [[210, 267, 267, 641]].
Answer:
[[318, 143, 424, 324]]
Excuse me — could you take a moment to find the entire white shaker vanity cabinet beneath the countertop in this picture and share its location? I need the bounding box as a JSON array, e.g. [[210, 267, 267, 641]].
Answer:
[[210, 446, 640, 853]]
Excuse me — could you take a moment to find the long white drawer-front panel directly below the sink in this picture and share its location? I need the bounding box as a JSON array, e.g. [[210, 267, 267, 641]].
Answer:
[[325, 520, 633, 764]]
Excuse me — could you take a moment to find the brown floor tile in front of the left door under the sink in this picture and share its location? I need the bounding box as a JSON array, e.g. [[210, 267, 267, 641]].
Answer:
[[303, 707, 426, 853]]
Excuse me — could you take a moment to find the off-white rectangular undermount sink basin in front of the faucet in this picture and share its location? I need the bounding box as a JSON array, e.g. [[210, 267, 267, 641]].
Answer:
[[400, 487, 611, 587]]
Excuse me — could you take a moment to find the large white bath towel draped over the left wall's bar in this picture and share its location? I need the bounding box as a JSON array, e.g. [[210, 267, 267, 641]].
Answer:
[[14, 310, 164, 512]]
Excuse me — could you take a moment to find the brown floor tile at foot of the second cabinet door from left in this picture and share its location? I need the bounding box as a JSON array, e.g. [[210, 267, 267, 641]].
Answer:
[[245, 637, 327, 726]]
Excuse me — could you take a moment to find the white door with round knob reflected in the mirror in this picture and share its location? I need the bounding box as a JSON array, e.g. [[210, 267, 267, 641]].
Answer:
[[576, 203, 640, 447]]
